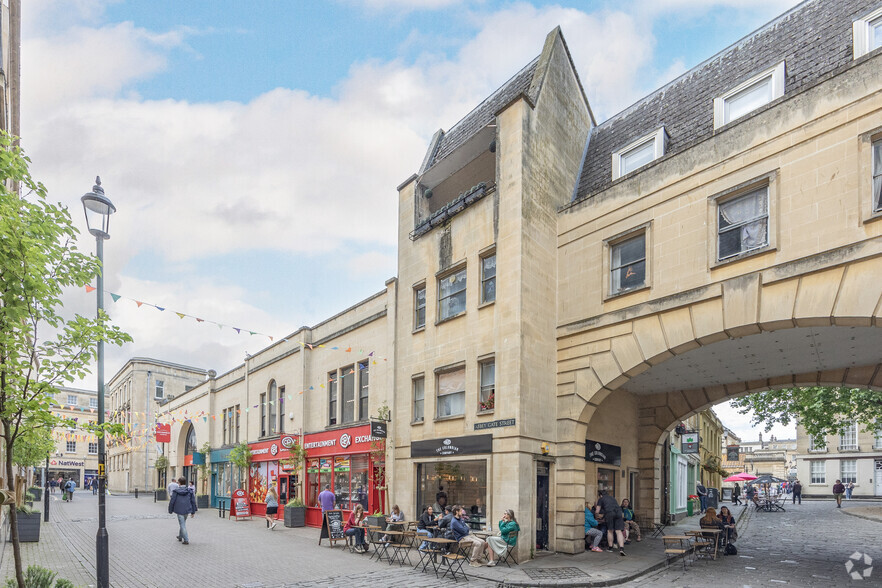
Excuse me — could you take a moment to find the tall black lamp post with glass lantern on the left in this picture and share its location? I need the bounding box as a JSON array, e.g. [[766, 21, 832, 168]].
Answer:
[[81, 177, 116, 588]]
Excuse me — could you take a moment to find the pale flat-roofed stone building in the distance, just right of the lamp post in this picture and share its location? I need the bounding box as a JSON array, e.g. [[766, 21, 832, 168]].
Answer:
[[106, 357, 206, 492]]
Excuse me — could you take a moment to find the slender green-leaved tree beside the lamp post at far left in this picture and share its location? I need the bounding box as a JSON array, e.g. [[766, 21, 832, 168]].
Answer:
[[0, 133, 132, 587]]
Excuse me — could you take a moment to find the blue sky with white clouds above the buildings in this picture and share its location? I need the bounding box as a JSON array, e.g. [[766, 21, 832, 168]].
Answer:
[[21, 0, 797, 440]]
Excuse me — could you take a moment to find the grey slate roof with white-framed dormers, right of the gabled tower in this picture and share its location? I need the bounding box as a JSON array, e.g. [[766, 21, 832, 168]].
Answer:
[[574, 0, 879, 200]]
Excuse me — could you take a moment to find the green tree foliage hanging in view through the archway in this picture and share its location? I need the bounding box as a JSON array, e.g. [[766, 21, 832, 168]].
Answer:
[[732, 386, 882, 447]]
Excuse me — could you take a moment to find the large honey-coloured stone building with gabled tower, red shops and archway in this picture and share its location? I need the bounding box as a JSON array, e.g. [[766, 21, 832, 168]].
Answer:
[[117, 0, 882, 558]]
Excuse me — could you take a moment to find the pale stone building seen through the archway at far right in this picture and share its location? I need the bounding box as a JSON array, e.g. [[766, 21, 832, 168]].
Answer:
[[796, 423, 882, 498]]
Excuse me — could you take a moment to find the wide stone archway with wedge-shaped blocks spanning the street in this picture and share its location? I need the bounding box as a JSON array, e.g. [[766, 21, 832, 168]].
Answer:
[[556, 257, 882, 553]]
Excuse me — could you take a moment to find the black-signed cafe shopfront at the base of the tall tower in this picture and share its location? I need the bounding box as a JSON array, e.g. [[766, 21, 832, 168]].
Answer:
[[410, 435, 493, 529]]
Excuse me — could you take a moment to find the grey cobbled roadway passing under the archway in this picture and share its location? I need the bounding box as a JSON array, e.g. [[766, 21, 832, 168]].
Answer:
[[624, 500, 882, 588]]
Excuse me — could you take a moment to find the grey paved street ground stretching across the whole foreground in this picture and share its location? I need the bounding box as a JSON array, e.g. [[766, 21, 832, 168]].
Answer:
[[0, 492, 882, 588]]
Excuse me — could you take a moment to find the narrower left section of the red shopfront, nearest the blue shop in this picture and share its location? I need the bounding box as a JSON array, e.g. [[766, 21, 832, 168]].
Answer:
[[248, 435, 298, 519]]
